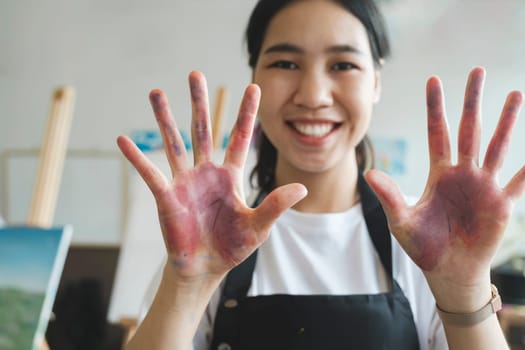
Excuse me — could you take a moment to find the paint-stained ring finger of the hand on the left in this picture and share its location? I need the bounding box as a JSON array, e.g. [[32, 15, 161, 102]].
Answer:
[[149, 90, 188, 176]]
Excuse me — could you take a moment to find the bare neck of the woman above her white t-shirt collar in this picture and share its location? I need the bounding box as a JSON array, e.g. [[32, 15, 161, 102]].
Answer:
[[276, 162, 359, 213]]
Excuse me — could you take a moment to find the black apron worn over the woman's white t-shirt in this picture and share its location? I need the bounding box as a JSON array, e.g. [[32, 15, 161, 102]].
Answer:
[[211, 174, 419, 350]]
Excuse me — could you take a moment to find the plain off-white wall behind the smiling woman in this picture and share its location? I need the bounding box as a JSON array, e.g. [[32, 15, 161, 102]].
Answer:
[[0, 0, 525, 235]]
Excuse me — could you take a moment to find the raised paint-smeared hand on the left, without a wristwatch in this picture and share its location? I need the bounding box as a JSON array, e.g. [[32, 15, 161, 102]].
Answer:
[[117, 71, 306, 282]]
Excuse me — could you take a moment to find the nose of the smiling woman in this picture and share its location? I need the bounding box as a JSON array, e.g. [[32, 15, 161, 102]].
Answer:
[[293, 69, 333, 109]]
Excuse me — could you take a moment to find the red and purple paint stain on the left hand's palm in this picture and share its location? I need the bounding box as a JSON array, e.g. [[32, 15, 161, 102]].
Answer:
[[159, 163, 256, 267]]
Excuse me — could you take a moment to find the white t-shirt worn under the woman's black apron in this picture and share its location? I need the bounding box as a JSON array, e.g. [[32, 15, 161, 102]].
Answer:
[[140, 204, 448, 350]]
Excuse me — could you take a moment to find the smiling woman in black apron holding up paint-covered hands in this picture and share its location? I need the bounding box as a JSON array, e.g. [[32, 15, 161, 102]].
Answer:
[[118, 0, 525, 349]]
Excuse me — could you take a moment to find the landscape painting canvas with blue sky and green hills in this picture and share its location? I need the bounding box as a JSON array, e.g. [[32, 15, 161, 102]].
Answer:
[[0, 225, 72, 350]]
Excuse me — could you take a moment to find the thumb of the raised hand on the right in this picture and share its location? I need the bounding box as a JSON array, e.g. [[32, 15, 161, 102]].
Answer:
[[365, 170, 407, 227]]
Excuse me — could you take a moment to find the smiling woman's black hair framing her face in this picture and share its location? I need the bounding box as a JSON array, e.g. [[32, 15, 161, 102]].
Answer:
[[245, 0, 390, 192]]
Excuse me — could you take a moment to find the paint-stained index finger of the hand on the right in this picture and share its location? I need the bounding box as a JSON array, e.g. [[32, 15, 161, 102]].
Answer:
[[427, 77, 450, 168]]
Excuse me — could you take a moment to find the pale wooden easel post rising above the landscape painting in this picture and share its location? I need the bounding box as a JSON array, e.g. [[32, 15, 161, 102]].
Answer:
[[27, 87, 75, 350]]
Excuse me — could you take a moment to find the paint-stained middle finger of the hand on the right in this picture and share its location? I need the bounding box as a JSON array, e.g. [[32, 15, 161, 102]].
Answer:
[[458, 67, 485, 165]]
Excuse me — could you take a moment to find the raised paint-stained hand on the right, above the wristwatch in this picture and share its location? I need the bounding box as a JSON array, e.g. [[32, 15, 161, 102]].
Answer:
[[366, 67, 525, 312]]
